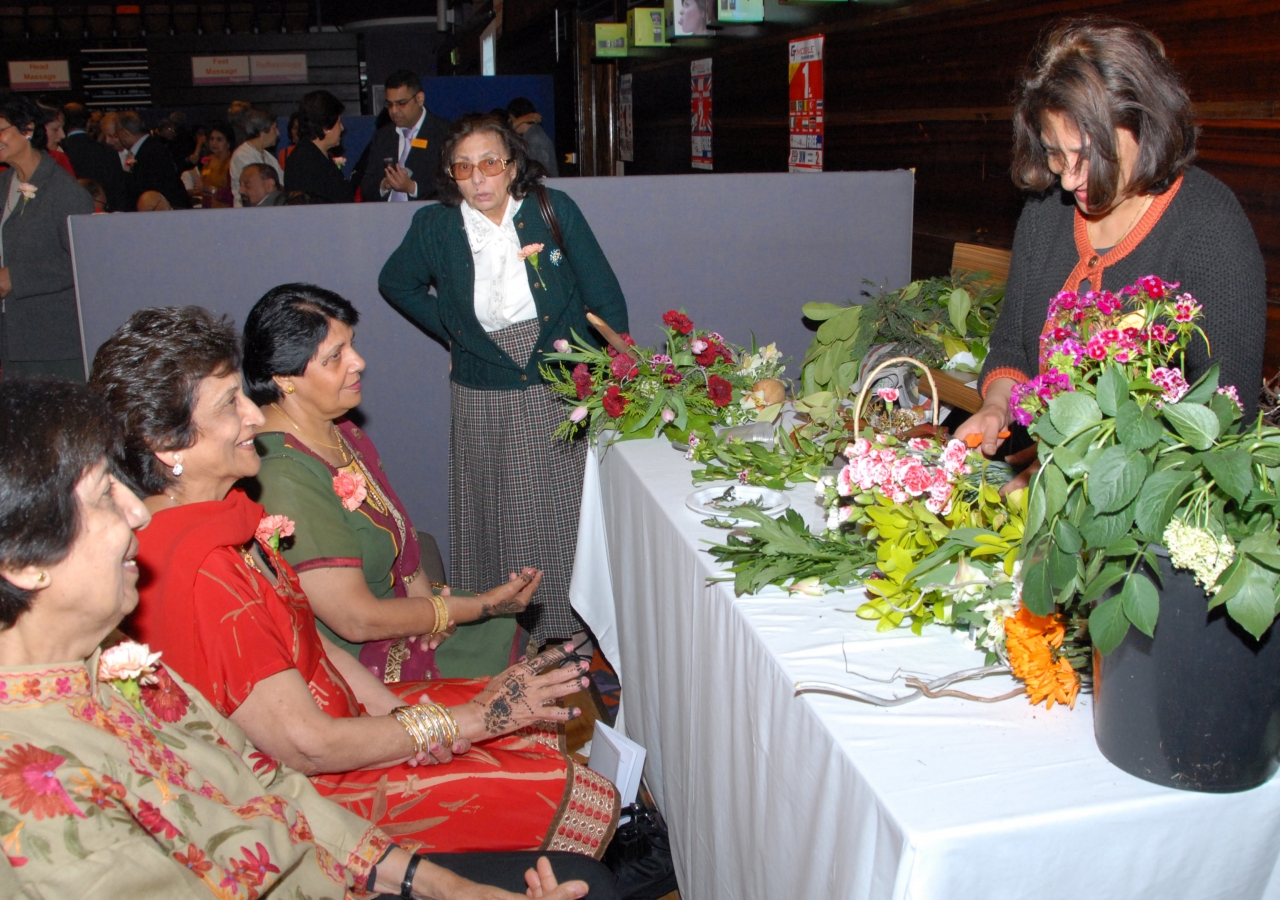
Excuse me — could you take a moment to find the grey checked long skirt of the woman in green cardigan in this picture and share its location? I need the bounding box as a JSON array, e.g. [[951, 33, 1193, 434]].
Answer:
[[449, 319, 586, 644]]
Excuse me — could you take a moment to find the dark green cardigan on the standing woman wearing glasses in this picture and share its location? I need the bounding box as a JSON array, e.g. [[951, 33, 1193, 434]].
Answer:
[[378, 191, 627, 390]]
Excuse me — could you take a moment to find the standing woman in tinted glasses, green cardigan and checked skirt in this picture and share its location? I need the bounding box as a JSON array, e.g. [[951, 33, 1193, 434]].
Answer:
[[378, 115, 627, 645]]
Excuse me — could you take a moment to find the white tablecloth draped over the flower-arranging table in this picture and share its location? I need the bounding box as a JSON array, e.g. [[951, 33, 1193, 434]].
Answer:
[[580, 440, 1280, 900]]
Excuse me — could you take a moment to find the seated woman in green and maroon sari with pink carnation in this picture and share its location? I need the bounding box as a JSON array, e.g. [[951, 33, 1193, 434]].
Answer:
[[243, 284, 524, 682]]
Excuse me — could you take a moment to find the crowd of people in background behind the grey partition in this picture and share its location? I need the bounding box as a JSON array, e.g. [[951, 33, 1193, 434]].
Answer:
[[6, 69, 559, 213]]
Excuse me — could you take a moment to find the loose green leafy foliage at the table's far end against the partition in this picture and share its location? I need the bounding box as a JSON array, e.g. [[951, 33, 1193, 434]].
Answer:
[[800, 271, 1005, 396]]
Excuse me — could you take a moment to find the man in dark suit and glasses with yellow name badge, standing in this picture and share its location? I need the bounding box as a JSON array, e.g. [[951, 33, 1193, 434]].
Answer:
[[360, 69, 449, 204]]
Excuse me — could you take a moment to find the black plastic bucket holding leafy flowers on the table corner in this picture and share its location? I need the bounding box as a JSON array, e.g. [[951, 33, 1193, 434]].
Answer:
[[1093, 548, 1280, 794]]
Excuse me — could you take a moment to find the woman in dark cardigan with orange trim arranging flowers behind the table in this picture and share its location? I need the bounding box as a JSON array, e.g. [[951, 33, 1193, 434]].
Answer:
[[956, 19, 1266, 454]]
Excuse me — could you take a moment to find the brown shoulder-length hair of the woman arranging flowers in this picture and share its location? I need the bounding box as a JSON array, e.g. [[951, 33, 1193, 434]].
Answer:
[[1012, 18, 1198, 211]]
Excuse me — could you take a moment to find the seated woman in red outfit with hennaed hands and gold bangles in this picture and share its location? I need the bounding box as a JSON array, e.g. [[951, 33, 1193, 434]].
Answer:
[[92, 307, 618, 858]]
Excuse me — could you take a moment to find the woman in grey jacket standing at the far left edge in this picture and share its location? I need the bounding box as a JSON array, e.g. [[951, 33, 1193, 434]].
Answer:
[[0, 91, 93, 382]]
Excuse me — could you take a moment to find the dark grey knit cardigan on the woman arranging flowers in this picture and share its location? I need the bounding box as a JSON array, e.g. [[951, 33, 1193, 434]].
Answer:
[[982, 166, 1266, 421]]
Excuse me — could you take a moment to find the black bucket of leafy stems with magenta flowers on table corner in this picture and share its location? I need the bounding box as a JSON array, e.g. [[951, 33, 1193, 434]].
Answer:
[[1010, 275, 1280, 791]]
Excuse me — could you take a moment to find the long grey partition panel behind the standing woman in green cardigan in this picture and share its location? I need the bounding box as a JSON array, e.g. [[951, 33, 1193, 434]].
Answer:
[[70, 172, 914, 565]]
